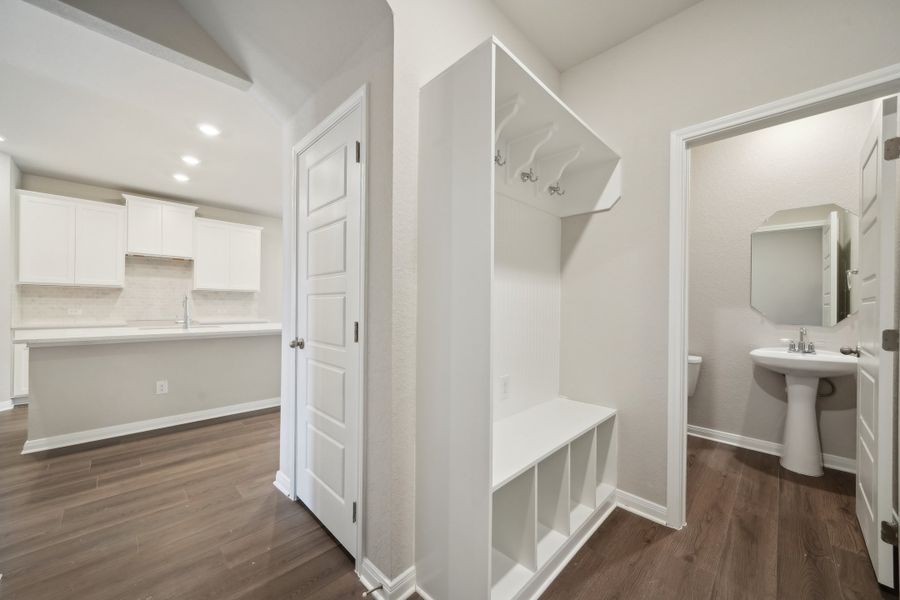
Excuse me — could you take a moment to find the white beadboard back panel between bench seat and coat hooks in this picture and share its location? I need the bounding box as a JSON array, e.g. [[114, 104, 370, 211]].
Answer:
[[492, 194, 561, 420]]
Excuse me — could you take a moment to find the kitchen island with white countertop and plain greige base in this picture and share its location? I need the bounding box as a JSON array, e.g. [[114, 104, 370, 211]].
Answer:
[[14, 322, 281, 453]]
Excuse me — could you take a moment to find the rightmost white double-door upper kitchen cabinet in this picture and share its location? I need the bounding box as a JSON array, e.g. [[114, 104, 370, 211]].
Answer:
[[194, 219, 262, 292]]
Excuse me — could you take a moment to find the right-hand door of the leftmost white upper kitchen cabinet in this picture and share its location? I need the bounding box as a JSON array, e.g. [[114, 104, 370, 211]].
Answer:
[[75, 203, 125, 287]]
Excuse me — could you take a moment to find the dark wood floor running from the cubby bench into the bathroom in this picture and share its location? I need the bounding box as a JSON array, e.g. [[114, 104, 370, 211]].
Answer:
[[542, 437, 895, 600]]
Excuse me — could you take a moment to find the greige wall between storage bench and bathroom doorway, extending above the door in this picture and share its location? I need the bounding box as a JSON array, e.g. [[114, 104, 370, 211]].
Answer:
[[556, 0, 900, 503]]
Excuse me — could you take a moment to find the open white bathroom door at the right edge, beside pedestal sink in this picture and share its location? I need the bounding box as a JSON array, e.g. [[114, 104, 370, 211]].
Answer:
[[856, 99, 896, 586]]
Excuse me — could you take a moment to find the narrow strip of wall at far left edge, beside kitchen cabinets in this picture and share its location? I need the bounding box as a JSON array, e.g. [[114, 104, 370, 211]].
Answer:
[[0, 153, 19, 410]]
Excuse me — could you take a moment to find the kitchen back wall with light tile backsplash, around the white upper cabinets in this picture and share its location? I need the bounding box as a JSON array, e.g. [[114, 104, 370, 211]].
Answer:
[[13, 173, 282, 327]]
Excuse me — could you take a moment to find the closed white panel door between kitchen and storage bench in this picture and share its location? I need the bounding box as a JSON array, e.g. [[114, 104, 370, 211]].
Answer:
[[296, 106, 362, 556]]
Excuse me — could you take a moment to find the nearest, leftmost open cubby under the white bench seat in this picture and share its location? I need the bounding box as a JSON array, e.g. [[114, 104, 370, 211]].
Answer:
[[491, 469, 537, 600]]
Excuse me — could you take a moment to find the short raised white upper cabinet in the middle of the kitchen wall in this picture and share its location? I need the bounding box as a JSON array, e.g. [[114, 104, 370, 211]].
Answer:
[[122, 194, 197, 260]]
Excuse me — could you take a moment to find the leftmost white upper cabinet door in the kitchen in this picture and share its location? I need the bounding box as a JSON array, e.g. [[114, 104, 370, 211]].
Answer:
[[19, 195, 75, 285]]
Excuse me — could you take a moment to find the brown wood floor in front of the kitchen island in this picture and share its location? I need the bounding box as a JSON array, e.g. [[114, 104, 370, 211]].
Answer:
[[0, 407, 363, 600]]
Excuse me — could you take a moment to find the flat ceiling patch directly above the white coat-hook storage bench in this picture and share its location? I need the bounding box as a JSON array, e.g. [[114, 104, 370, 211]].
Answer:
[[494, 0, 700, 71]]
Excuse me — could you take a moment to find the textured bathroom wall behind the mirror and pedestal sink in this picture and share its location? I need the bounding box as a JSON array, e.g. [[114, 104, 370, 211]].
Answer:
[[688, 103, 873, 458]]
